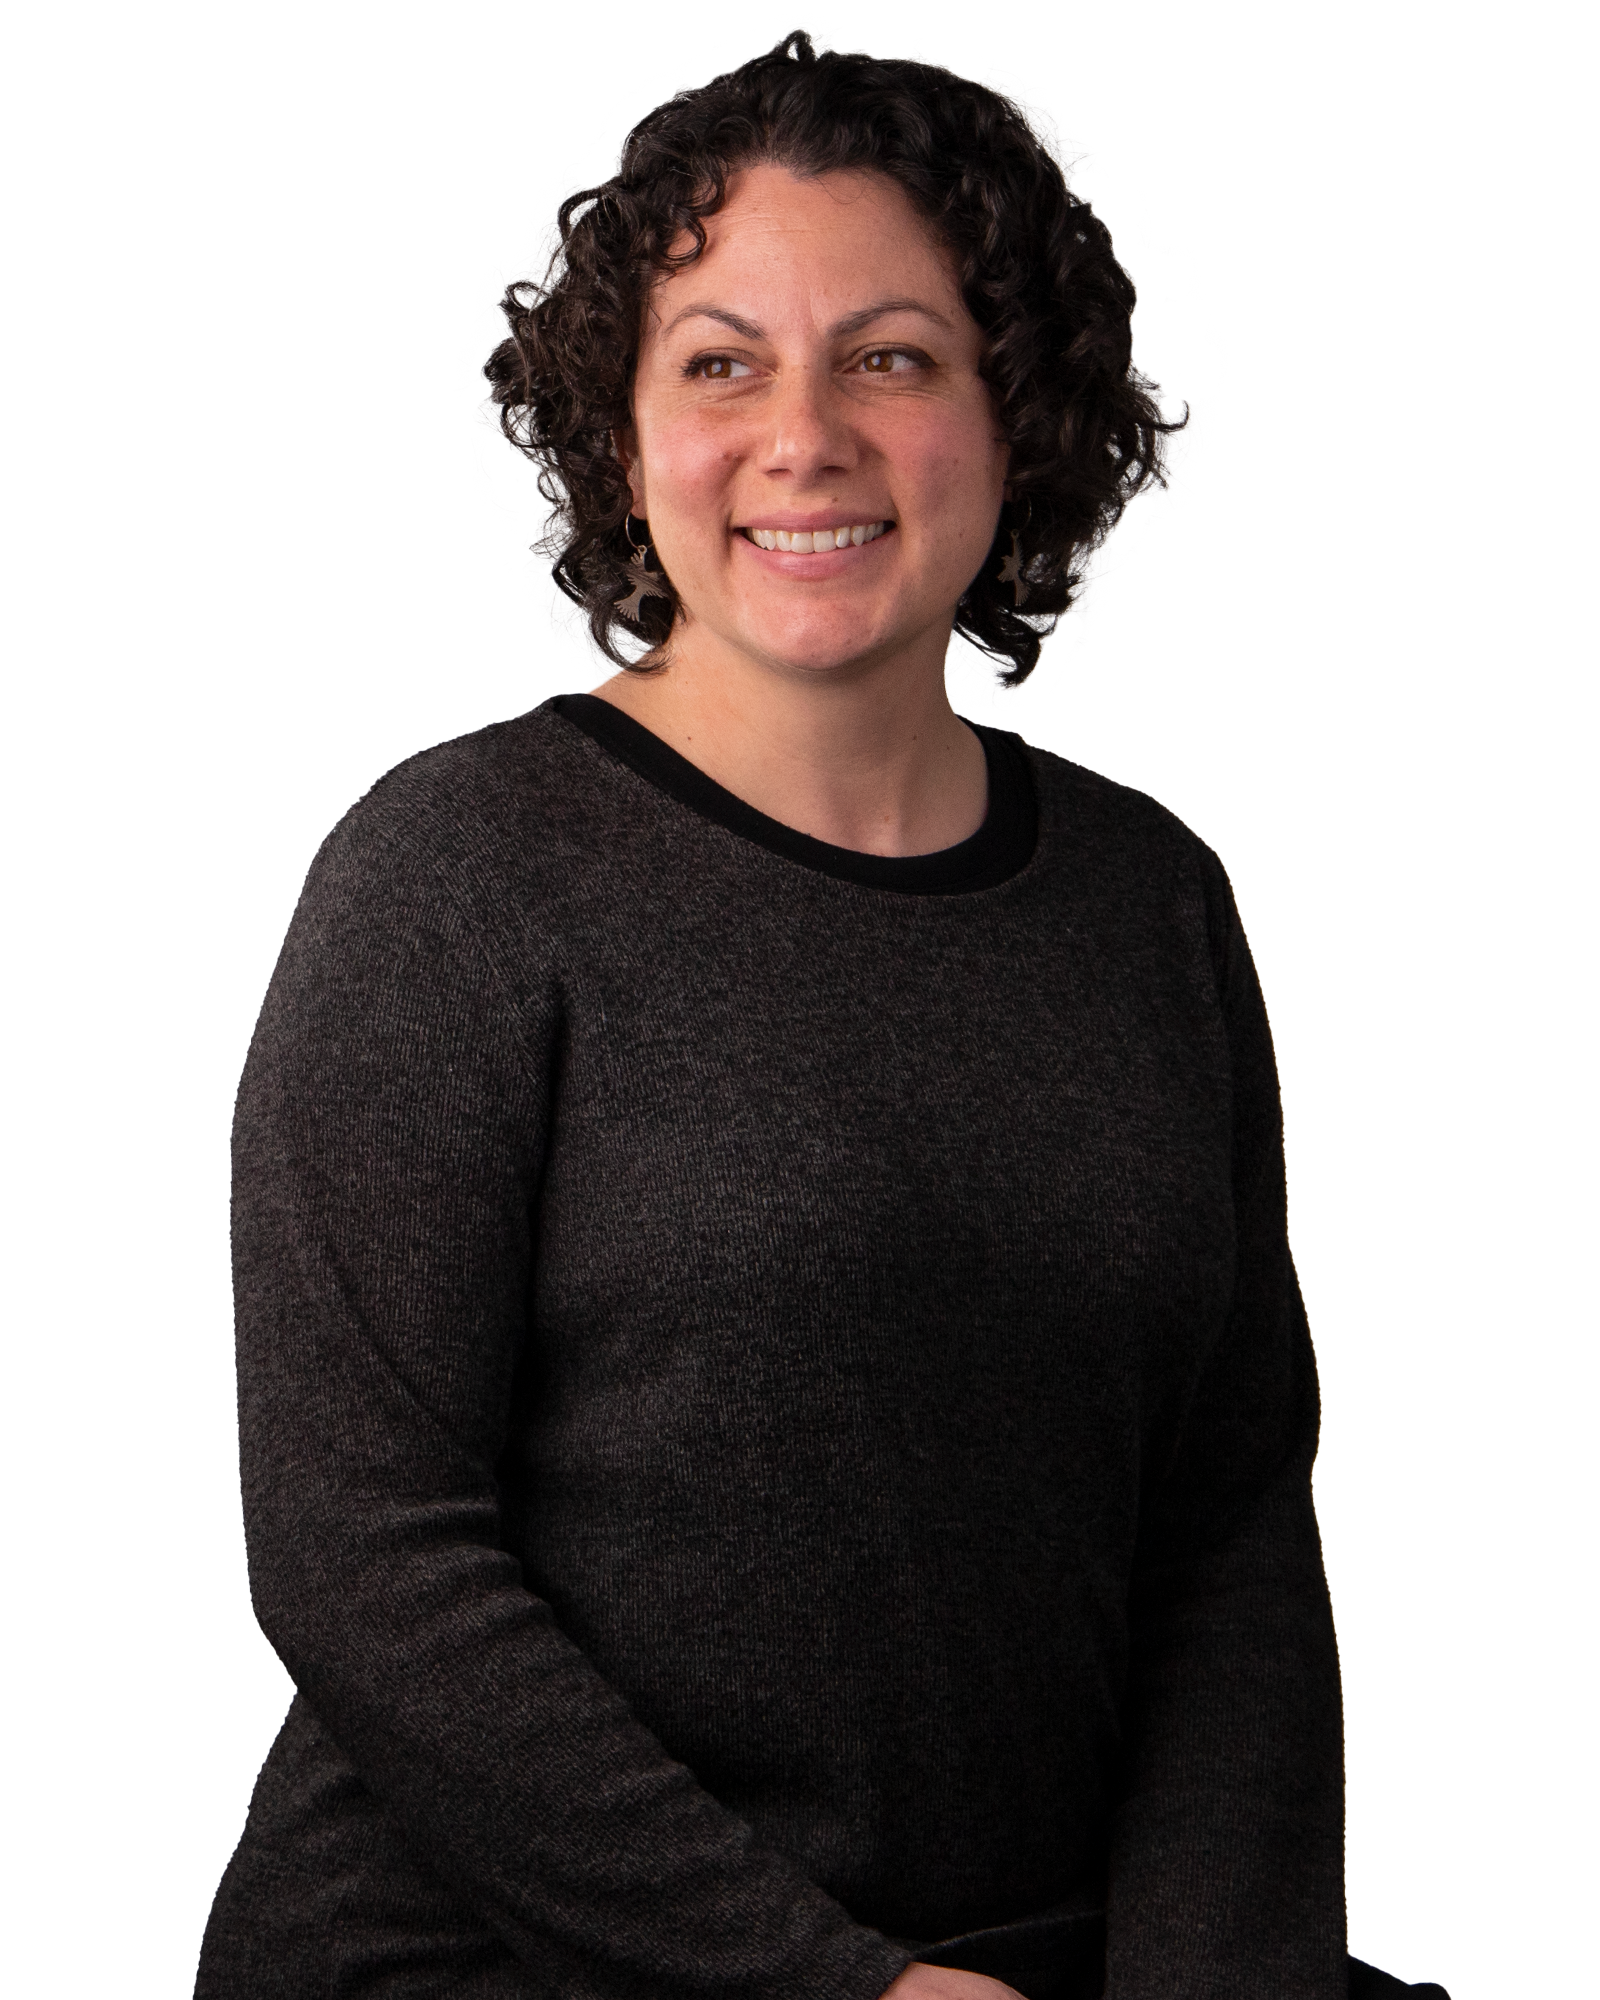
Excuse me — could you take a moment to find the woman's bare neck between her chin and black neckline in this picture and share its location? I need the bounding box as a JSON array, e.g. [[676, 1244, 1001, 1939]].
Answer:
[[588, 616, 988, 854]]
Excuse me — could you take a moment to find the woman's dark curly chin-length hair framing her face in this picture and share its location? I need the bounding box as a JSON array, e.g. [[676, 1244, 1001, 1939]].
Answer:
[[484, 28, 1182, 686]]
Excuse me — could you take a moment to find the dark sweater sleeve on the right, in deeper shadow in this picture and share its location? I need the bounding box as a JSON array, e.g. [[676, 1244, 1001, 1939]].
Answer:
[[1106, 854, 1346, 2000]]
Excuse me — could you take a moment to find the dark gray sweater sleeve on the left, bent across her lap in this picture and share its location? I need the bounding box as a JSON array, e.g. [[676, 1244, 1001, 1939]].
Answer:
[[234, 788, 910, 2000]]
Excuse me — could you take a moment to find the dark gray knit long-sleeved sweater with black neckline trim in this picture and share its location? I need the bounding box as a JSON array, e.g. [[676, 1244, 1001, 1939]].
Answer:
[[198, 698, 1346, 2000]]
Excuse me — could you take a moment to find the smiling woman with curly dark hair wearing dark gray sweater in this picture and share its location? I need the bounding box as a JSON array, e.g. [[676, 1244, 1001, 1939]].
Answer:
[[198, 34, 1448, 2000]]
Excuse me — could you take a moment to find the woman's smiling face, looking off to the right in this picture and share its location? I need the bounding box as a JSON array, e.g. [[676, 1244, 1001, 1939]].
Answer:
[[620, 166, 1008, 674]]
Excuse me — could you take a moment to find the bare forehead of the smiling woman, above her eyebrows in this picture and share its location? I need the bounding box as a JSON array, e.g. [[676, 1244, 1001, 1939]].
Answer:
[[652, 162, 960, 318]]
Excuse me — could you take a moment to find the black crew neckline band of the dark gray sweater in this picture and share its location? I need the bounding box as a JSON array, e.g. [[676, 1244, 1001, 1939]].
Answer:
[[550, 694, 1038, 896]]
